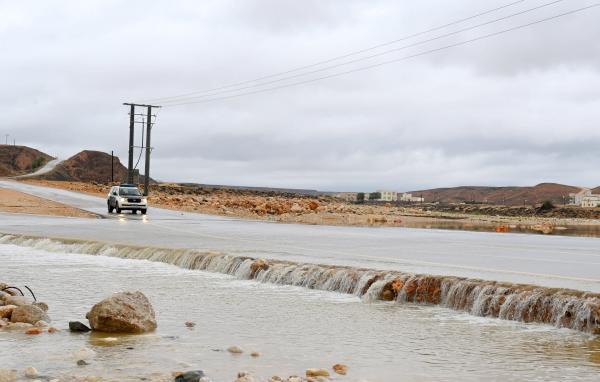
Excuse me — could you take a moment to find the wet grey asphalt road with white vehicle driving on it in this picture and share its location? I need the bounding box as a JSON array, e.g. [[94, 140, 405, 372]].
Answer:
[[0, 181, 600, 292]]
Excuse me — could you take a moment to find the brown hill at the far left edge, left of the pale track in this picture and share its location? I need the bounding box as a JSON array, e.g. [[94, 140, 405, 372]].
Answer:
[[0, 145, 52, 176]]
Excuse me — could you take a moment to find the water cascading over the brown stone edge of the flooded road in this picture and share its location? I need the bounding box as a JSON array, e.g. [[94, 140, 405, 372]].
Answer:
[[0, 234, 600, 335]]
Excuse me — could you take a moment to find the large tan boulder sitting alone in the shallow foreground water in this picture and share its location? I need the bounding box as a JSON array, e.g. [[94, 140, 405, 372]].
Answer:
[[86, 292, 156, 333]]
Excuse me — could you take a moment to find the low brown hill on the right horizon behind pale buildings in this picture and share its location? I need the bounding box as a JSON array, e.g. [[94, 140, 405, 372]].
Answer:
[[412, 183, 580, 205]]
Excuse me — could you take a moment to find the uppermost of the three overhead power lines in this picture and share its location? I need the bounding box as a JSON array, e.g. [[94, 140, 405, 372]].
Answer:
[[139, 0, 526, 102]]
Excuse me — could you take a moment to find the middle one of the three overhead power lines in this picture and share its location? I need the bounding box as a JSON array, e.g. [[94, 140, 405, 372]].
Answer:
[[157, 0, 564, 103]]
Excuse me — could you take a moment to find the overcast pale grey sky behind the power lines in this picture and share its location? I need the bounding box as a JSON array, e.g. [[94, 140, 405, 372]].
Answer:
[[0, 0, 600, 191]]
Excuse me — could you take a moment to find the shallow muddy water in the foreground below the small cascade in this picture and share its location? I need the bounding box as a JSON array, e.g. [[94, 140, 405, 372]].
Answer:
[[0, 244, 600, 381]]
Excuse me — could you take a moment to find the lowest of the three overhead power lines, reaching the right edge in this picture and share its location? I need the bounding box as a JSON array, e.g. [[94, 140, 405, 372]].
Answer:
[[164, 3, 600, 107]]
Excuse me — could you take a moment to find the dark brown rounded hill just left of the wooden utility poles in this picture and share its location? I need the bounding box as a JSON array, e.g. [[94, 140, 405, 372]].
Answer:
[[38, 150, 152, 183]]
